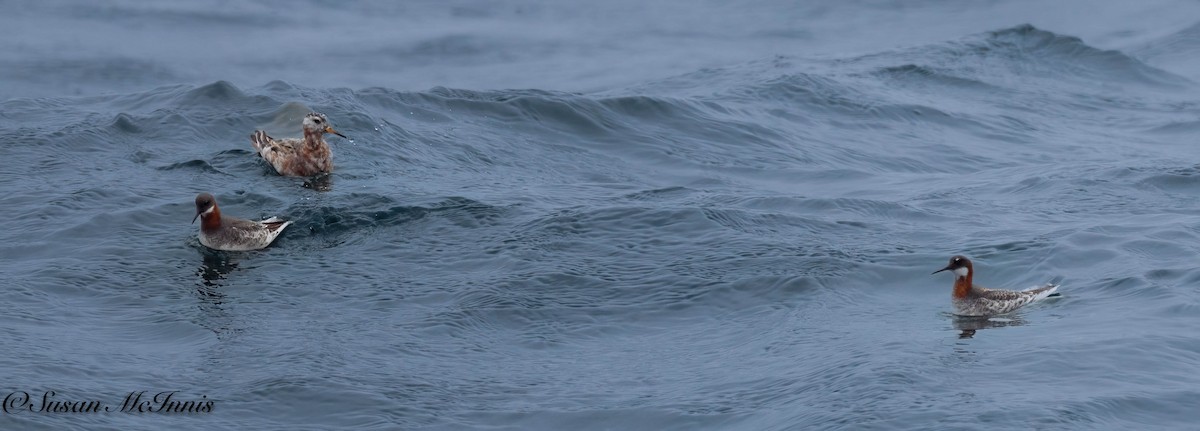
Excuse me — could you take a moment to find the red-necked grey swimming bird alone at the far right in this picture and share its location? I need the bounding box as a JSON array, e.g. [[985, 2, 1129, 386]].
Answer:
[[934, 256, 1058, 317]]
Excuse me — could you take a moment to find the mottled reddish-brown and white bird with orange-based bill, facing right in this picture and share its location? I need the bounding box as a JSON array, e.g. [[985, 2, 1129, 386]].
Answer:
[[250, 112, 346, 176]]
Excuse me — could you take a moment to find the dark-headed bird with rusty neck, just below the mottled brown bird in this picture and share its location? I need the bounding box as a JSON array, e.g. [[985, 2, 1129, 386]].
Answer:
[[192, 193, 292, 251]]
